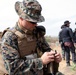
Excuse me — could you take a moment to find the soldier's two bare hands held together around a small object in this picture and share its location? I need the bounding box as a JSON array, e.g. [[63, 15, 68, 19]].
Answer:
[[41, 51, 62, 65]]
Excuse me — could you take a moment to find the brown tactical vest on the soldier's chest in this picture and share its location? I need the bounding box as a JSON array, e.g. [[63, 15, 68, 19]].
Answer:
[[1, 24, 45, 75]]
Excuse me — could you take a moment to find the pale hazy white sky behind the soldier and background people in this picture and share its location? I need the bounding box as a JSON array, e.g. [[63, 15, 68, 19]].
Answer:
[[0, 0, 76, 36]]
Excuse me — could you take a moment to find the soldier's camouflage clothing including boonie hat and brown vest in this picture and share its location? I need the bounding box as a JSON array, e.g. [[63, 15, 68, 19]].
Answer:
[[1, 0, 50, 75]]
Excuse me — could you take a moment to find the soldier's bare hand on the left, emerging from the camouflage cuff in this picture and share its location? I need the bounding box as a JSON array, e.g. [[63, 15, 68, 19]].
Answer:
[[41, 51, 55, 65]]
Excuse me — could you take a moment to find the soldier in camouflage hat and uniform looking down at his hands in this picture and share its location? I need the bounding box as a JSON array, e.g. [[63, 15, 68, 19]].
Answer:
[[1, 0, 61, 75]]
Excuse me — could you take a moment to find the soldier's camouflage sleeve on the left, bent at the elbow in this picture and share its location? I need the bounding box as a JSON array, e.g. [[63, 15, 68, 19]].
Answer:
[[1, 31, 43, 75]]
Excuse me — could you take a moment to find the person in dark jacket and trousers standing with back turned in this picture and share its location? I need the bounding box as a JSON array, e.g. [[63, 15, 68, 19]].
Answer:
[[61, 20, 76, 66]]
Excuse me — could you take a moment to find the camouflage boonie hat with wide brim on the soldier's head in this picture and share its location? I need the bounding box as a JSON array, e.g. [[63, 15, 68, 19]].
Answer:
[[15, 0, 44, 22]]
